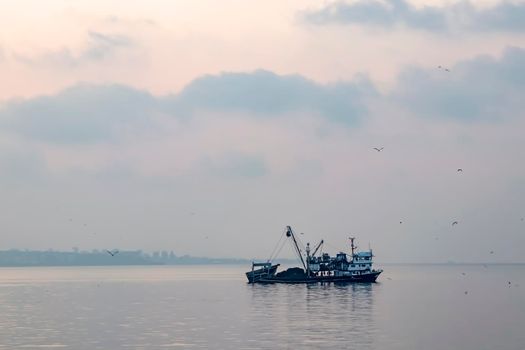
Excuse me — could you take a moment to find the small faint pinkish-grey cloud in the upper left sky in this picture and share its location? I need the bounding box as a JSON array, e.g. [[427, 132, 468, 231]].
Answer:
[[13, 31, 135, 68]]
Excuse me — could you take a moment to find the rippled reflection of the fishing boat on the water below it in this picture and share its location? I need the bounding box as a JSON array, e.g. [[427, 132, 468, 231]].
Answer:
[[247, 282, 381, 349]]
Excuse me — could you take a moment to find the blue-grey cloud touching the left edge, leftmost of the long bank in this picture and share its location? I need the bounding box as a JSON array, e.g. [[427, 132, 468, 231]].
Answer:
[[0, 85, 159, 144]]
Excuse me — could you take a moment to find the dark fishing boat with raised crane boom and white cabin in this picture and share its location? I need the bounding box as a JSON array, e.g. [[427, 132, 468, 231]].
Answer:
[[246, 226, 383, 283]]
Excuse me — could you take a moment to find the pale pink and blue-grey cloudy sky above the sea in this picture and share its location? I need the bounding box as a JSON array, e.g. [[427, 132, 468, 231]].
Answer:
[[0, 0, 525, 263]]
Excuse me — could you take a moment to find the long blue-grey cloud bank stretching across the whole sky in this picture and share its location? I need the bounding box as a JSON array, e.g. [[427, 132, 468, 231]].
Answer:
[[0, 47, 525, 144]]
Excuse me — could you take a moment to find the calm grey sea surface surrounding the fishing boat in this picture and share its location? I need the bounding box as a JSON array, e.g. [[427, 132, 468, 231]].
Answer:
[[0, 265, 525, 350]]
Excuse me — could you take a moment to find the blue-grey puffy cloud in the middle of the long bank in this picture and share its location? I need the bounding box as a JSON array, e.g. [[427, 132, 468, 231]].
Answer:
[[173, 70, 374, 124]]
